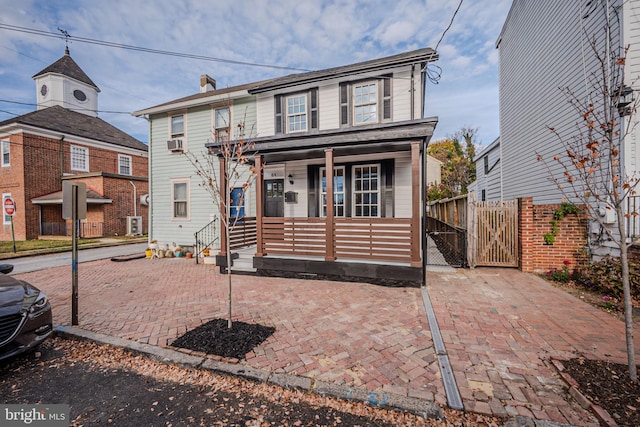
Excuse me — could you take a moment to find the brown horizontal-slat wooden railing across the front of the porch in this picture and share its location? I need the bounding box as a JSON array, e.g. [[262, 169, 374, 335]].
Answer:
[[262, 218, 419, 262]]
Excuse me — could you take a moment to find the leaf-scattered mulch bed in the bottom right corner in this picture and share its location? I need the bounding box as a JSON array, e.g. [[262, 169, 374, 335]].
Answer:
[[562, 358, 640, 426]]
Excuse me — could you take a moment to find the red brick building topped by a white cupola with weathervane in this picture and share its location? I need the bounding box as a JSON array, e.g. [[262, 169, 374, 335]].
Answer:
[[0, 49, 148, 240]]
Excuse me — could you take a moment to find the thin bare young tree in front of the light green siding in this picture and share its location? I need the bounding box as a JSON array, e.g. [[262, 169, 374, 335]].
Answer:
[[184, 113, 260, 329]]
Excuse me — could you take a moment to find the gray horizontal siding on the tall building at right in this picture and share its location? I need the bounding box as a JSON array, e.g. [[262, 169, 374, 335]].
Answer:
[[498, 0, 615, 204]]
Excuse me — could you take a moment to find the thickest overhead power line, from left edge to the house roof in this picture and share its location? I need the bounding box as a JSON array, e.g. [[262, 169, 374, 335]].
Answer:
[[0, 24, 311, 71]]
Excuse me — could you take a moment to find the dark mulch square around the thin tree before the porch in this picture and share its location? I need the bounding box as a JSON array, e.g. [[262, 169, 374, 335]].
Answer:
[[171, 319, 276, 359]]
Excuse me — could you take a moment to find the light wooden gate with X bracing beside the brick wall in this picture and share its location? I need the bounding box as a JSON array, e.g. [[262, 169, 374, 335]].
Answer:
[[469, 200, 519, 267]]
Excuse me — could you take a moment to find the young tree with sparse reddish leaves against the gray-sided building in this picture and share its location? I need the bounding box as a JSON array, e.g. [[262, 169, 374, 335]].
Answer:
[[538, 39, 639, 381]]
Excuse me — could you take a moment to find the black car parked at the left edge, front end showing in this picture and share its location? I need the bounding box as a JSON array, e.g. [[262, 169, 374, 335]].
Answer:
[[0, 264, 53, 360]]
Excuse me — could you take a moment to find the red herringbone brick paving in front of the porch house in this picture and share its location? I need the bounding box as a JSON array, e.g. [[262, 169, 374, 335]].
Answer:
[[11, 258, 640, 426]]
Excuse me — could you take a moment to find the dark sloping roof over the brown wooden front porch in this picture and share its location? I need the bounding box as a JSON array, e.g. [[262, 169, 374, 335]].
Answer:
[[205, 117, 438, 162]]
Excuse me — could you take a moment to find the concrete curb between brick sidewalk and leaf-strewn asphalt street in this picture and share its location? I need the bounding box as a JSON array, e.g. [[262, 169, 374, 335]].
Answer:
[[55, 326, 444, 420]]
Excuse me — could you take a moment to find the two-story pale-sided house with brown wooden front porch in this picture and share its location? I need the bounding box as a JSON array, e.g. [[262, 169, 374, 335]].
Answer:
[[134, 48, 437, 283]]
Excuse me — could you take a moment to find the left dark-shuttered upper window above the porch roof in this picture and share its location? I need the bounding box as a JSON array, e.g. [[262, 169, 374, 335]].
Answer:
[[275, 88, 318, 133]]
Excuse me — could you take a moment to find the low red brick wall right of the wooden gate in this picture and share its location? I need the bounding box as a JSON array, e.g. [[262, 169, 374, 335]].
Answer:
[[519, 197, 588, 273]]
